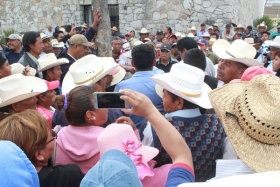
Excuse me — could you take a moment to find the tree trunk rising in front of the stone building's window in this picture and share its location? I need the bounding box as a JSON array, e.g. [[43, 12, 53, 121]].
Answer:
[[92, 0, 112, 57]]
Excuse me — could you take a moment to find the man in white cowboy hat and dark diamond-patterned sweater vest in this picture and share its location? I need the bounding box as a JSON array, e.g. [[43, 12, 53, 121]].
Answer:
[[143, 62, 225, 181]]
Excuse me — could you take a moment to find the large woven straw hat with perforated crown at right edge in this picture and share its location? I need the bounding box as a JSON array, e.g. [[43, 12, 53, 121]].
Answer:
[[209, 74, 280, 172]]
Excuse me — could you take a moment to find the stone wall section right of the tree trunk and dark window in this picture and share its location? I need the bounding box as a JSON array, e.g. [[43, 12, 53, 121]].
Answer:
[[119, 0, 261, 34]]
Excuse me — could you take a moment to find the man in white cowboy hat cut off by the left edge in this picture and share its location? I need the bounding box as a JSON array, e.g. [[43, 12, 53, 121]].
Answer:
[[0, 74, 47, 120]]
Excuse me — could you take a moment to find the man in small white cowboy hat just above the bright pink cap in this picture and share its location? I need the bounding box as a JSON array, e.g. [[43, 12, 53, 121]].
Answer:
[[38, 53, 69, 94]]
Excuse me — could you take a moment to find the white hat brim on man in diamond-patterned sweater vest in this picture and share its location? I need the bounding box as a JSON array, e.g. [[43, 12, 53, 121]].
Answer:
[[152, 73, 213, 109]]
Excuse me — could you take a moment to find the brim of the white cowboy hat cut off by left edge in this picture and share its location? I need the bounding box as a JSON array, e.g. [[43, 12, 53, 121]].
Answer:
[[0, 76, 48, 108]]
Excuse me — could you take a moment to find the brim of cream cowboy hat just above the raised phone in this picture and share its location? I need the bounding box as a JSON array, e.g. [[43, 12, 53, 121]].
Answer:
[[62, 62, 118, 94]]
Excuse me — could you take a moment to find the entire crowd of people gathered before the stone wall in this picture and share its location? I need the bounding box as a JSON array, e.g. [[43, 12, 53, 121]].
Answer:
[[0, 11, 280, 187]]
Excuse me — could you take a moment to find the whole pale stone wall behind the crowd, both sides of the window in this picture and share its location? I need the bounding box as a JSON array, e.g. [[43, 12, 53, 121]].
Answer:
[[0, 0, 264, 34]]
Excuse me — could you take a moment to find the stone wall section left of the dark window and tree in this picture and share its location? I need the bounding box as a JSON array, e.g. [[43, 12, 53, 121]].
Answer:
[[0, 0, 91, 32]]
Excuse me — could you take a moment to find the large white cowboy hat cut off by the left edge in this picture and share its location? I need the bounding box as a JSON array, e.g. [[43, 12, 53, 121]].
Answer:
[[0, 74, 48, 107]]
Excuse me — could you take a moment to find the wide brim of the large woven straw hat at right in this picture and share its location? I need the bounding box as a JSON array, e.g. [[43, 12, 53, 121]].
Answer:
[[209, 82, 280, 172]]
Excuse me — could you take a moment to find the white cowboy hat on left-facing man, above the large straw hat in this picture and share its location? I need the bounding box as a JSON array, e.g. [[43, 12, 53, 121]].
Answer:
[[212, 39, 261, 67]]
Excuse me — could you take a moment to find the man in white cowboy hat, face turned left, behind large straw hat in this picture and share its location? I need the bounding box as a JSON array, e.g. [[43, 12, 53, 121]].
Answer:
[[212, 39, 261, 84]]
